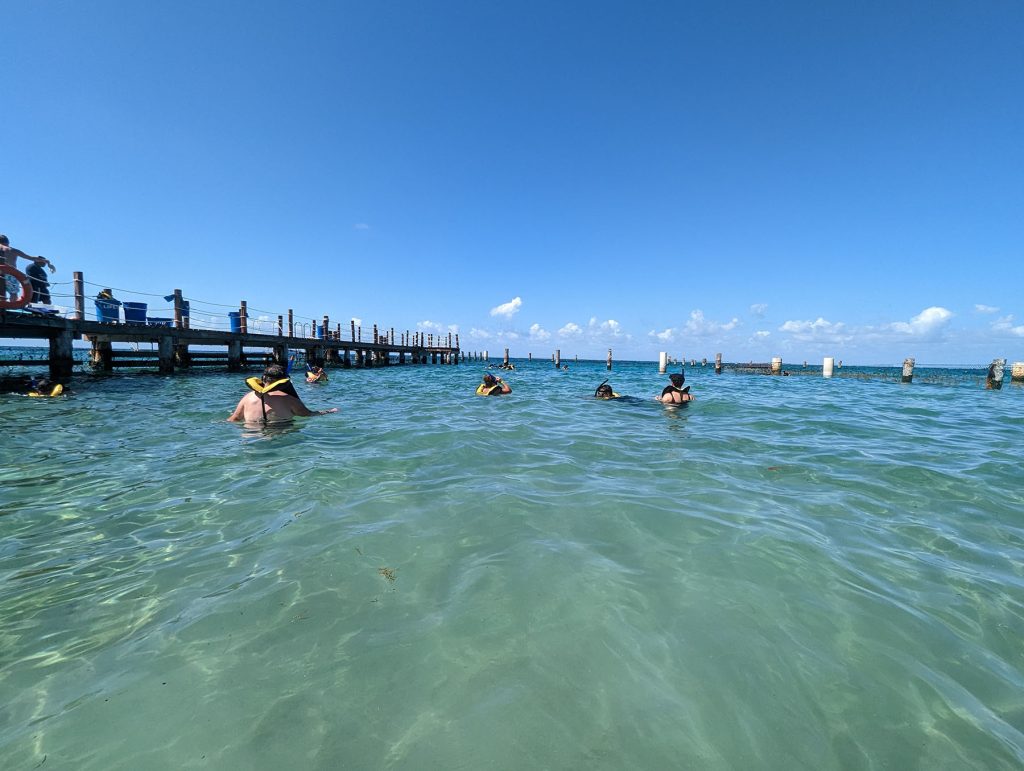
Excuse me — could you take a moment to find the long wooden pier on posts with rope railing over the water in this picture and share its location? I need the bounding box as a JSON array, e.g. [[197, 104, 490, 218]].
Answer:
[[0, 273, 460, 382]]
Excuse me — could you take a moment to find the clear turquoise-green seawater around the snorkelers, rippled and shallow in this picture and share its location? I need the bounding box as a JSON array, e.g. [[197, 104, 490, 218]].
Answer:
[[0, 362, 1024, 769]]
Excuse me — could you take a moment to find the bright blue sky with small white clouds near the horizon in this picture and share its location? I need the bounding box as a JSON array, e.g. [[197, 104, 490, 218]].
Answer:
[[0, 0, 1024, 365]]
